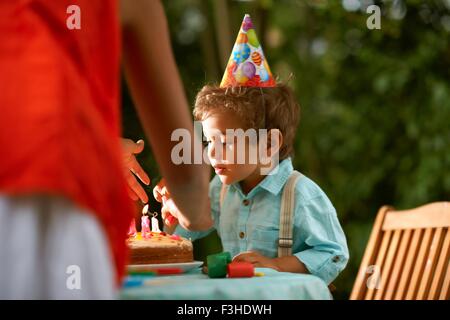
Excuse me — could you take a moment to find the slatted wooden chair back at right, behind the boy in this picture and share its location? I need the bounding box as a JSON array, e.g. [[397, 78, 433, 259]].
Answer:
[[350, 202, 450, 300]]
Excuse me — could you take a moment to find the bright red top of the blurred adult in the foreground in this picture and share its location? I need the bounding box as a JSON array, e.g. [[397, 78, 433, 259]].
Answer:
[[0, 0, 133, 279]]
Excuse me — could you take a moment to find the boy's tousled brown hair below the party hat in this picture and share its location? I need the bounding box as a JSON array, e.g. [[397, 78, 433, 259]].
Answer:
[[194, 84, 300, 160]]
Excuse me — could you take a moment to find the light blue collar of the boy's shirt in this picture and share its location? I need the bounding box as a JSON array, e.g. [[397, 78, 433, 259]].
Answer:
[[232, 158, 294, 197]]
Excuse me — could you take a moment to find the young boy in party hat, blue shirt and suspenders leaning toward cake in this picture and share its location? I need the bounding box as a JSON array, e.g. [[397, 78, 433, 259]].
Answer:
[[154, 16, 349, 283]]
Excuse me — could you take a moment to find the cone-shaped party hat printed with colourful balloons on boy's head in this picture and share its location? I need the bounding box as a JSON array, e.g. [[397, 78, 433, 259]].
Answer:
[[220, 14, 276, 88]]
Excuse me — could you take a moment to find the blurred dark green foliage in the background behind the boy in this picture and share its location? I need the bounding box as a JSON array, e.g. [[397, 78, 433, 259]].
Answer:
[[123, 0, 450, 299]]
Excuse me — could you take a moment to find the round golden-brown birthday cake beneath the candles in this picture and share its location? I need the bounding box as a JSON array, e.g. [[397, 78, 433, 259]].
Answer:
[[127, 232, 194, 264]]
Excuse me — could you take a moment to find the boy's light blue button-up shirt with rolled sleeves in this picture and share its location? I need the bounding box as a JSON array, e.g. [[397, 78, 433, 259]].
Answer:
[[175, 158, 349, 283]]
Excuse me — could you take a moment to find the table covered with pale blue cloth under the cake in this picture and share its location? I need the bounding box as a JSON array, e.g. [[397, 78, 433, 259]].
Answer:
[[120, 268, 332, 300]]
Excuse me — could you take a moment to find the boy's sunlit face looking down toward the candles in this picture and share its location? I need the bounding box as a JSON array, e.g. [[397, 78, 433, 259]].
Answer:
[[202, 112, 259, 185]]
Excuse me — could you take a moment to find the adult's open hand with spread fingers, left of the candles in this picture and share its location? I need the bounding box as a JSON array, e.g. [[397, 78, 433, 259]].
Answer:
[[120, 138, 150, 203]]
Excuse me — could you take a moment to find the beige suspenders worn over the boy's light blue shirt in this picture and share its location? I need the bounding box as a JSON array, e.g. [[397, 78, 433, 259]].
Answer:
[[219, 170, 301, 257]]
